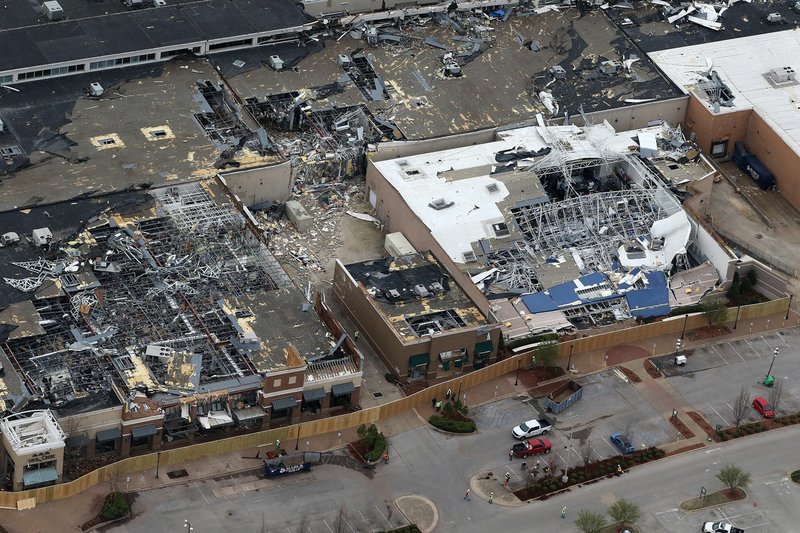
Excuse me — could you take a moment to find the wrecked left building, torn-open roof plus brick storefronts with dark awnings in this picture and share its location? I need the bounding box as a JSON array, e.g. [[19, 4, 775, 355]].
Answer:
[[0, 179, 362, 490]]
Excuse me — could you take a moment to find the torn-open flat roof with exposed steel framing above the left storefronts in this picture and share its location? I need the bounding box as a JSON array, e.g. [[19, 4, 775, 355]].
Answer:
[[0, 179, 336, 414]]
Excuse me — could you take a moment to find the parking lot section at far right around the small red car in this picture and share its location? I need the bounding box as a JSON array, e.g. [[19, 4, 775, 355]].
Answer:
[[658, 326, 800, 427]]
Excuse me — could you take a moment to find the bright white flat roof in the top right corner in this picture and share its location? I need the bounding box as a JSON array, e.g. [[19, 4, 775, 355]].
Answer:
[[650, 28, 800, 153]]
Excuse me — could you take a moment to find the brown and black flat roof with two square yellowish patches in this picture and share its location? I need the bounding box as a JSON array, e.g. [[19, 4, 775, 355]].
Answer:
[[0, 56, 282, 209]]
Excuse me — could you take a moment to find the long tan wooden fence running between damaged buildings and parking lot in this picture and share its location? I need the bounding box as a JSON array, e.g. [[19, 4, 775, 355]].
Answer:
[[0, 297, 789, 508]]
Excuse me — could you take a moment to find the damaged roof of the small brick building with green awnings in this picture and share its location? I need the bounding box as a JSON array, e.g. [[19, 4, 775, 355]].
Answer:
[[345, 253, 488, 340]]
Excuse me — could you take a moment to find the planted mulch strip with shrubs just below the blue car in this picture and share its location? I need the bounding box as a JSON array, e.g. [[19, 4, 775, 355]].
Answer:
[[514, 448, 665, 501]]
